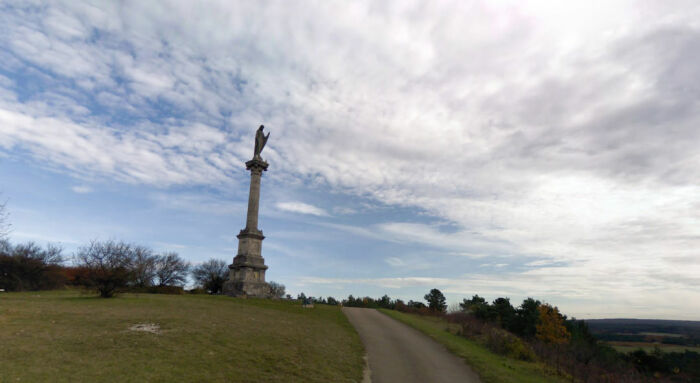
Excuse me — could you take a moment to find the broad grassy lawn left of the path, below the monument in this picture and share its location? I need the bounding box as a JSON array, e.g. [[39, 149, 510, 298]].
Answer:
[[0, 290, 364, 383]]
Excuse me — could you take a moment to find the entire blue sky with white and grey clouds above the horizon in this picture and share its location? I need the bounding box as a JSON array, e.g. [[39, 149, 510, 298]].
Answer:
[[0, 0, 700, 319]]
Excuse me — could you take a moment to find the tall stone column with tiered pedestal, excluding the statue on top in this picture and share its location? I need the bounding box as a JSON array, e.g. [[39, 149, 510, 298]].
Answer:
[[223, 156, 270, 297]]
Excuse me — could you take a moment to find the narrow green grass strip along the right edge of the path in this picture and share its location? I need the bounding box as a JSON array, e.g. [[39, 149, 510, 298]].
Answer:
[[379, 309, 566, 383]]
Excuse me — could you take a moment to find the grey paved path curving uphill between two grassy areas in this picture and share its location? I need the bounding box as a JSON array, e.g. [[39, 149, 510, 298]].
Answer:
[[343, 307, 481, 383]]
